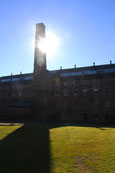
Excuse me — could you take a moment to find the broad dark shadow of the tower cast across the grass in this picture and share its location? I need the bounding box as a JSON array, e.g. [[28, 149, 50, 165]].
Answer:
[[0, 125, 53, 173]]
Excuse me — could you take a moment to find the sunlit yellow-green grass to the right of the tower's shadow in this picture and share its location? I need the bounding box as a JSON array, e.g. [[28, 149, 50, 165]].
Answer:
[[50, 126, 115, 173]]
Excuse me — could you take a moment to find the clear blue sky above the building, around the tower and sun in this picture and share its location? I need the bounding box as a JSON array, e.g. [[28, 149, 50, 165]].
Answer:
[[0, 0, 115, 76]]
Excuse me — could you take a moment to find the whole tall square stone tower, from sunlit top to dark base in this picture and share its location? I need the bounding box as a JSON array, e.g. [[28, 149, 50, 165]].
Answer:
[[33, 23, 49, 119]]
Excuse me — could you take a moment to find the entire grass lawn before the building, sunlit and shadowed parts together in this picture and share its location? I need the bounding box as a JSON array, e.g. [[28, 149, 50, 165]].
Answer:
[[0, 124, 115, 173]]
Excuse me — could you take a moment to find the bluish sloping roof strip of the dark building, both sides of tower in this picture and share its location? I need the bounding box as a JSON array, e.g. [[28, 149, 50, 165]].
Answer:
[[0, 64, 115, 83]]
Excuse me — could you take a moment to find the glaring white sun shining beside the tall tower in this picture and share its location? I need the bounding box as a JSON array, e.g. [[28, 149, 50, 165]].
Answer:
[[38, 31, 60, 57]]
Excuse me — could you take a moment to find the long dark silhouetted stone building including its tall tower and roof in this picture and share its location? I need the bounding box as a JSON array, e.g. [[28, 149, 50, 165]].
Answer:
[[0, 23, 115, 123]]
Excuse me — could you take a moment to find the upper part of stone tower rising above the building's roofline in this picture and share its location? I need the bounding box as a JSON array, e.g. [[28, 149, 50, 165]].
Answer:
[[34, 23, 46, 77]]
